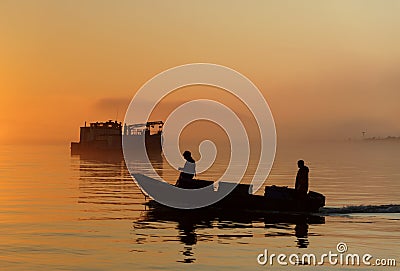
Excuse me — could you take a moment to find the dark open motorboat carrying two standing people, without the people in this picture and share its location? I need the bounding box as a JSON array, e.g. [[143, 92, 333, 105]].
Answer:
[[139, 175, 325, 212]]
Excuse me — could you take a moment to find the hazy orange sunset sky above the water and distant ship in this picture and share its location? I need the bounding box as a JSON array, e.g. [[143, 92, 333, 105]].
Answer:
[[0, 0, 400, 143]]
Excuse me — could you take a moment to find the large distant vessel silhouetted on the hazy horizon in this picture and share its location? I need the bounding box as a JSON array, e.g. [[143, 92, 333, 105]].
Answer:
[[71, 120, 164, 154]]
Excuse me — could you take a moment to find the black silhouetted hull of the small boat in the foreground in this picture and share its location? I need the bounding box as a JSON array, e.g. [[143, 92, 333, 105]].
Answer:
[[133, 174, 325, 215]]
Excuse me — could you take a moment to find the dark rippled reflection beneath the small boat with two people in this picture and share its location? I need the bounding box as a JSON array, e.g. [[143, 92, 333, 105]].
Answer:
[[138, 201, 325, 254]]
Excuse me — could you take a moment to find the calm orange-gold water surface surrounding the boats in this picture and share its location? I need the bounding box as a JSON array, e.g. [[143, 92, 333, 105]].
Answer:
[[0, 142, 400, 270]]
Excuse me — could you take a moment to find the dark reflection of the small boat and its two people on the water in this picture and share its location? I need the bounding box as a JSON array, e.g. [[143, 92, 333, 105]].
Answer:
[[138, 206, 325, 263]]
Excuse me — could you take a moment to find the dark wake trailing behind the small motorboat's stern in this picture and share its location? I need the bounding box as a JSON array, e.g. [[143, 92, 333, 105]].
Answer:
[[320, 204, 400, 214]]
